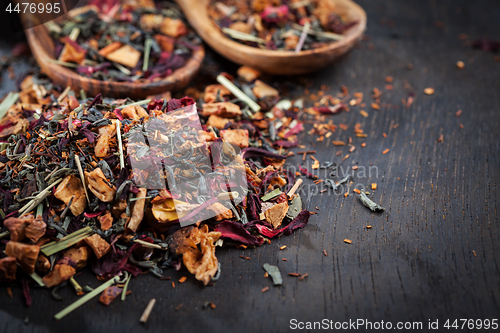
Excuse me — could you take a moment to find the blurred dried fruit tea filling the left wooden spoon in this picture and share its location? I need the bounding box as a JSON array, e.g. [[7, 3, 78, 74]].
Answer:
[[46, 0, 201, 82]]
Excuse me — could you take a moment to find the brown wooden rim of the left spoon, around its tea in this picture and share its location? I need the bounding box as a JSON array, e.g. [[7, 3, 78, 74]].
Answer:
[[26, 25, 205, 99]]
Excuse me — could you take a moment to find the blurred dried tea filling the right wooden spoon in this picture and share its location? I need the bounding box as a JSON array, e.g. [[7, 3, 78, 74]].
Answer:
[[208, 0, 357, 52]]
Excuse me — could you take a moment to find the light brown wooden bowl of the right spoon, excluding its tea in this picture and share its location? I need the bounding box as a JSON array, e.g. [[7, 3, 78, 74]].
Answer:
[[176, 0, 366, 75]]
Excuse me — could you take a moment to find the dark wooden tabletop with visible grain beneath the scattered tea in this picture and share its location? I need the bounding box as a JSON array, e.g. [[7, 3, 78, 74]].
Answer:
[[0, 0, 500, 332]]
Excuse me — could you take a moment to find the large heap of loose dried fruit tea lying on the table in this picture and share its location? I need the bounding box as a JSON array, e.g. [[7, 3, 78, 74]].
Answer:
[[0, 69, 311, 319]]
